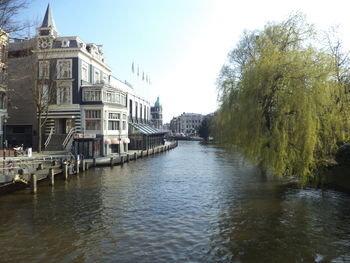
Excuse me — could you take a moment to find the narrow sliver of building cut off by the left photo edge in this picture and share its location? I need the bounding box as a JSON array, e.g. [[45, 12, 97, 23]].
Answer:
[[0, 29, 8, 147]]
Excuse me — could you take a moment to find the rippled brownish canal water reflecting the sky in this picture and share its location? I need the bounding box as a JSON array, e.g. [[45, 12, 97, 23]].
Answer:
[[0, 142, 350, 263]]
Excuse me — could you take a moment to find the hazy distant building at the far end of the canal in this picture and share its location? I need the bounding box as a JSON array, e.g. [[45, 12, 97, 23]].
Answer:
[[170, 112, 203, 136]]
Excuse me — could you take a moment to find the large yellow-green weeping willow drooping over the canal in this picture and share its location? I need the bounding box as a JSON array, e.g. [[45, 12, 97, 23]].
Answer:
[[215, 14, 349, 177]]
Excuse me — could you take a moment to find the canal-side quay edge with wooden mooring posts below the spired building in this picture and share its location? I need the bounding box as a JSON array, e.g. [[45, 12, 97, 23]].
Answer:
[[0, 142, 178, 194]]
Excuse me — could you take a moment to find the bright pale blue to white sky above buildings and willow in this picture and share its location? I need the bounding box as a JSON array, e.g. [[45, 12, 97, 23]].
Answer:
[[18, 0, 350, 122]]
